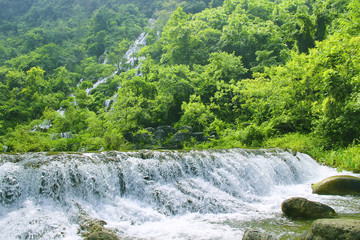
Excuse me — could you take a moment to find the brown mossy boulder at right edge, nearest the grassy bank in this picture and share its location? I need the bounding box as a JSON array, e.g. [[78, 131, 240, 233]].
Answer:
[[311, 175, 360, 195]]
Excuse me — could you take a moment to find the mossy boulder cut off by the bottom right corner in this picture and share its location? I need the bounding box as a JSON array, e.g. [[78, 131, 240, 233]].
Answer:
[[301, 219, 360, 240]]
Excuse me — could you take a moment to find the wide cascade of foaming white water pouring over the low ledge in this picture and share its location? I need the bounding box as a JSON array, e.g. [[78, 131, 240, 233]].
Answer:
[[0, 149, 360, 239]]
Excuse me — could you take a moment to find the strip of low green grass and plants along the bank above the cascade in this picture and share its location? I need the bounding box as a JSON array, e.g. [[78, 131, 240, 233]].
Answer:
[[0, 130, 360, 173]]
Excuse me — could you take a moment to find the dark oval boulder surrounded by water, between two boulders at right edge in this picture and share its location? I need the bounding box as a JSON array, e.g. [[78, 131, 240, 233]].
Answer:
[[281, 197, 336, 219]]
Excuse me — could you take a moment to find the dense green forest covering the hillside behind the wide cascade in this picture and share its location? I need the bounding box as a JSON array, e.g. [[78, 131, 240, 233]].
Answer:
[[0, 0, 360, 170]]
